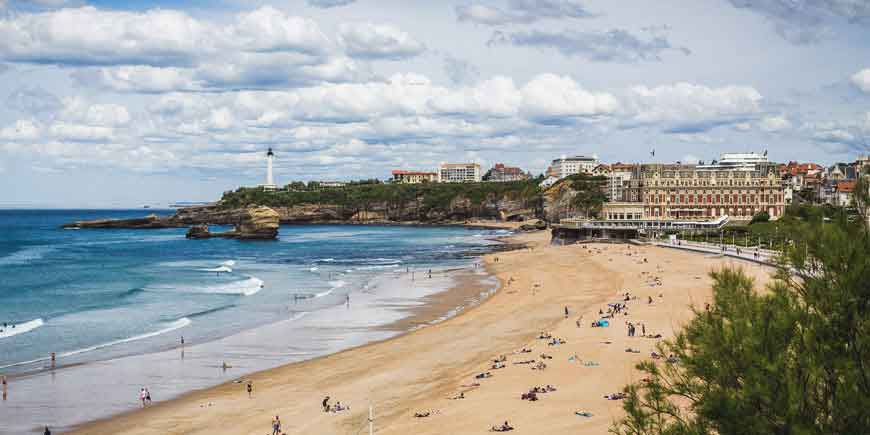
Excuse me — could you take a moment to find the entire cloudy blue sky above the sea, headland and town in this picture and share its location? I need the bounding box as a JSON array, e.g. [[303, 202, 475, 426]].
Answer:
[[0, 0, 870, 207]]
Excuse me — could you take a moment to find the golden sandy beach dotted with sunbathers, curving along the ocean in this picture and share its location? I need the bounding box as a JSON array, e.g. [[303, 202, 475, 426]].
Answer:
[[75, 231, 771, 435]]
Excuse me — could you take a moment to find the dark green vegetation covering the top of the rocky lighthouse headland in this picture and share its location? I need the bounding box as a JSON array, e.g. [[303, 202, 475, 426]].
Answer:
[[220, 180, 541, 218]]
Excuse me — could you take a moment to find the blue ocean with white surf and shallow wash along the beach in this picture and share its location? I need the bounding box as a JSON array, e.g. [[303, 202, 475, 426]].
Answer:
[[0, 210, 505, 433]]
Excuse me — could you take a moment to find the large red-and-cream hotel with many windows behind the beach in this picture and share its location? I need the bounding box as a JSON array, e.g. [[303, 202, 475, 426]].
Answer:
[[602, 153, 785, 221]]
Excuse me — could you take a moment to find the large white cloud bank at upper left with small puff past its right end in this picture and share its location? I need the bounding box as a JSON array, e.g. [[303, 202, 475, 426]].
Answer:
[[0, 6, 364, 92]]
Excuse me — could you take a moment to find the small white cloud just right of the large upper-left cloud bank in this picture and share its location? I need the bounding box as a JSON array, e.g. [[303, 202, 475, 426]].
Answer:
[[338, 23, 426, 60]]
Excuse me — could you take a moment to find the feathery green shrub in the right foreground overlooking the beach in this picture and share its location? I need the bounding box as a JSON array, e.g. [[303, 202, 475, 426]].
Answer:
[[611, 216, 870, 435]]
